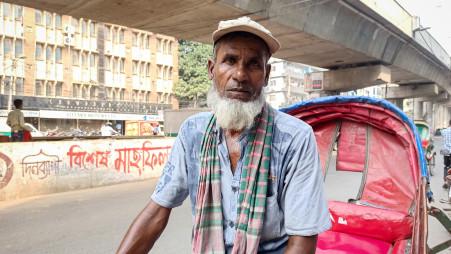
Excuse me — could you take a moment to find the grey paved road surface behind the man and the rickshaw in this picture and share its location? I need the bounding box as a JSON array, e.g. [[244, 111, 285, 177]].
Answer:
[[0, 137, 451, 254]]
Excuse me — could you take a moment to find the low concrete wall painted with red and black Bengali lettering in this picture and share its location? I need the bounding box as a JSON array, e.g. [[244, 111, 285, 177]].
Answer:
[[0, 138, 174, 200]]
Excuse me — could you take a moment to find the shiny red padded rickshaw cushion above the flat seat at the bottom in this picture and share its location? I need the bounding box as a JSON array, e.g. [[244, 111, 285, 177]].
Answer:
[[328, 201, 413, 243]]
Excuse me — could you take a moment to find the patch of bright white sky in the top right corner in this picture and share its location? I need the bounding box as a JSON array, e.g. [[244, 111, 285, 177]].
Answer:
[[396, 0, 451, 56]]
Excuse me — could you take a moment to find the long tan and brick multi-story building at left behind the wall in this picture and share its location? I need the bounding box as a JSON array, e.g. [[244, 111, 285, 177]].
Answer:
[[0, 3, 178, 133]]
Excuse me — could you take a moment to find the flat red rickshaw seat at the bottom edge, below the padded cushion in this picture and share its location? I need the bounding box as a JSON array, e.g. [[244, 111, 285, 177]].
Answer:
[[316, 230, 391, 254]]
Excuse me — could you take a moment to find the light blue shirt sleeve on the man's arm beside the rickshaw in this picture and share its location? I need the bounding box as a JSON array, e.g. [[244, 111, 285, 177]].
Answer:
[[281, 128, 332, 236]]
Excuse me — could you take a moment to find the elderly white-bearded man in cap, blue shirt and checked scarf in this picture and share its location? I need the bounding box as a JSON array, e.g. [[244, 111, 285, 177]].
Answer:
[[118, 17, 331, 254]]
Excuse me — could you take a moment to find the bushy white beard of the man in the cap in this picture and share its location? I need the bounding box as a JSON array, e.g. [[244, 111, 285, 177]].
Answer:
[[207, 83, 265, 131]]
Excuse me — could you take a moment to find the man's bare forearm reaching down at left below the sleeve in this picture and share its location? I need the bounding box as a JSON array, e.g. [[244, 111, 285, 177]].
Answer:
[[117, 200, 172, 254]]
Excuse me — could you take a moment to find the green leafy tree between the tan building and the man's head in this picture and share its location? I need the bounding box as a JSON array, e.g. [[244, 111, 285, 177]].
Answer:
[[174, 40, 213, 107]]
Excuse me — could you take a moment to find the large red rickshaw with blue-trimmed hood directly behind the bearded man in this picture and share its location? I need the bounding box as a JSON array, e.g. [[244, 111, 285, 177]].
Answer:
[[280, 96, 451, 254]]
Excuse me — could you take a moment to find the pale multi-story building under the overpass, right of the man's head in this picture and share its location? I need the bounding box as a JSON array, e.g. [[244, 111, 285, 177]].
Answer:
[[265, 58, 316, 109]]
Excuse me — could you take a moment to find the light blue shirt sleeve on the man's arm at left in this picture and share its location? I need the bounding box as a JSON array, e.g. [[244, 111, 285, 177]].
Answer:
[[152, 125, 189, 208]]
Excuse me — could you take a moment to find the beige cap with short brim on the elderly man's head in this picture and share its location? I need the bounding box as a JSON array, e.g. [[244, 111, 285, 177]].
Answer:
[[213, 17, 280, 55]]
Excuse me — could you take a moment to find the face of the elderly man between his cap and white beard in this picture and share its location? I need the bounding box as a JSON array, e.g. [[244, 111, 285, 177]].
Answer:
[[208, 37, 271, 102]]
